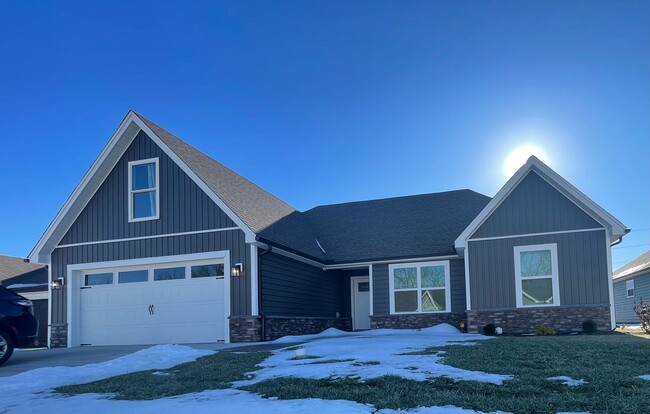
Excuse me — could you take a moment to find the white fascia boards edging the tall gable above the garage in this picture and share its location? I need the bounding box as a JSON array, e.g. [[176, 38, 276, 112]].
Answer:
[[28, 111, 255, 264]]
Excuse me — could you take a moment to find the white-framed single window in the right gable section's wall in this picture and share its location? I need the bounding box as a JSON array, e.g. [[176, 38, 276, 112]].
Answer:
[[514, 244, 560, 308]]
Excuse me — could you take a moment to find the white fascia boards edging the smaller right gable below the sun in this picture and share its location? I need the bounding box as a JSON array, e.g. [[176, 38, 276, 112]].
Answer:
[[454, 156, 626, 254]]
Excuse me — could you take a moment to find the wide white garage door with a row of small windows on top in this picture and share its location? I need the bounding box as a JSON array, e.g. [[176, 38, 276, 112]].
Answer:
[[79, 260, 226, 345]]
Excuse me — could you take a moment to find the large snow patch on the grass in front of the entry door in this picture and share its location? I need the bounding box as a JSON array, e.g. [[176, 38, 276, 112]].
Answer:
[[236, 324, 512, 386]]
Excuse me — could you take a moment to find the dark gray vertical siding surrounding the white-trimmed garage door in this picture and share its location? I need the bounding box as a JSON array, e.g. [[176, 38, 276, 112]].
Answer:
[[52, 230, 251, 324]]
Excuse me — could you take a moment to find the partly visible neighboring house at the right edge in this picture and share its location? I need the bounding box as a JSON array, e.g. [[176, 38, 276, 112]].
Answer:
[[614, 250, 650, 325]]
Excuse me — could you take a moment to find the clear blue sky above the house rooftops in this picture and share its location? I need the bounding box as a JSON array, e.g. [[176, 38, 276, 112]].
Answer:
[[0, 1, 650, 268]]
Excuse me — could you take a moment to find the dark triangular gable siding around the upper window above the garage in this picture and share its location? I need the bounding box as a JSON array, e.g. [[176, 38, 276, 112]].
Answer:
[[59, 131, 236, 245]]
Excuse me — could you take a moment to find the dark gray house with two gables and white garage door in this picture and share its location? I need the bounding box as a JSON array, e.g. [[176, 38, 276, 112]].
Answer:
[[29, 112, 629, 347]]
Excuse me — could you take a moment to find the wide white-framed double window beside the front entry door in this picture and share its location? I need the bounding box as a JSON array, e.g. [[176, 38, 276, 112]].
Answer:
[[389, 261, 451, 313]]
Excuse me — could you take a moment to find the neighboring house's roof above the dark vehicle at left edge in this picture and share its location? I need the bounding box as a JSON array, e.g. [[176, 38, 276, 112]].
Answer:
[[0, 256, 47, 292]]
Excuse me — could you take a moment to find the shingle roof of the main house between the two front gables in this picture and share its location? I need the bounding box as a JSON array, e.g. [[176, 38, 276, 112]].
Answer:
[[138, 115, 490, 263]]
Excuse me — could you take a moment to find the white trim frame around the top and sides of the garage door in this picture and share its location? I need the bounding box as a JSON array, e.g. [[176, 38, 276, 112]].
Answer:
[[65, 250, 231, 348]]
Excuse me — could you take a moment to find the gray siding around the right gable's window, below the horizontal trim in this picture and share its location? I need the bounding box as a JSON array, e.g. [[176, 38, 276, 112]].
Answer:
[[469, 229, 609, 310]]
